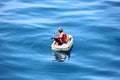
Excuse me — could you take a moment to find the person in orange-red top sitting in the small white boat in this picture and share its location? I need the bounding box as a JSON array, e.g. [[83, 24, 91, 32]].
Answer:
[[51, 28, 67, 45]]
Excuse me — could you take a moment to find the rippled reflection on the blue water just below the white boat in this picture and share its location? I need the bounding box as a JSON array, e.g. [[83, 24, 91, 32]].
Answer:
[[52, 51, 70, 62]]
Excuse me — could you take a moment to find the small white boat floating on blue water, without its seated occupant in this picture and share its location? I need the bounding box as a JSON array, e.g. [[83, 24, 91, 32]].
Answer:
[[51, 34, 73, 51]]
